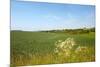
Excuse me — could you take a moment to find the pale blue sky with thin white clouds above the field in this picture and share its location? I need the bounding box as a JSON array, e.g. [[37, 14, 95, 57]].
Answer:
[[11, 0, 95, 31]]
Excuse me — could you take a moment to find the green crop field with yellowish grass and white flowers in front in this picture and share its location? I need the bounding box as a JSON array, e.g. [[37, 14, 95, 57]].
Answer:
[[11, 31, 95, 66]]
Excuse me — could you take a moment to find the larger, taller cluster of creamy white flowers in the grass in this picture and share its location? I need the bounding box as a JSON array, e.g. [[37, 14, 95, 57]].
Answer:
[[54, 38, 76, 56]]
